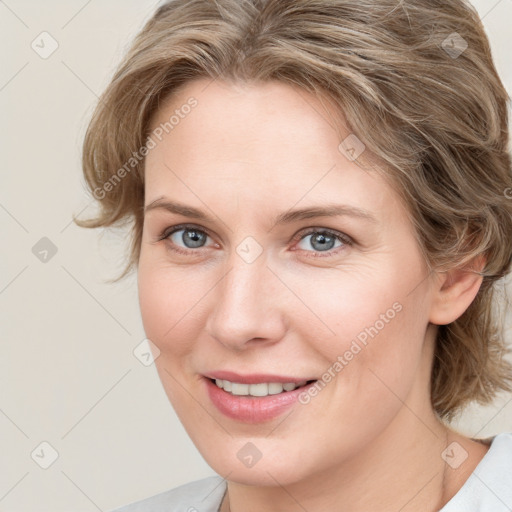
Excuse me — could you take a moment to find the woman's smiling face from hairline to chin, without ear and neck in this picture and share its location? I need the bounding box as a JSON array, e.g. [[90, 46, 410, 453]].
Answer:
[[138, 80, 435, 485]]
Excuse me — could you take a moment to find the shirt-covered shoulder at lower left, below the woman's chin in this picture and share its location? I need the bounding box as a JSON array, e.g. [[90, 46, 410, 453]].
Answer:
[[112, 476, 226, 512]]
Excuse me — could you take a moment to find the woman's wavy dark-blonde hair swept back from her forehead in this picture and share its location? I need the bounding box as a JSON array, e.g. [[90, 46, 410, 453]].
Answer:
[[75, 0, 512, 419]]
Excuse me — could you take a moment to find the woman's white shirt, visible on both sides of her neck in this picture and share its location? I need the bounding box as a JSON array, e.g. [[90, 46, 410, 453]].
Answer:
[[113, 433, 512, 512]]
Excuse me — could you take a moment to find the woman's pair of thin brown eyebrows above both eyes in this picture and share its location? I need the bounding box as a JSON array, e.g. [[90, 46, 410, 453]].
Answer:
[[144, 197, 377, 225]]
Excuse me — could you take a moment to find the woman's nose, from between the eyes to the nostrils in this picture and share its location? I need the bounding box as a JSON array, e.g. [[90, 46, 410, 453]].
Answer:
[[206, 253, 286, 351]]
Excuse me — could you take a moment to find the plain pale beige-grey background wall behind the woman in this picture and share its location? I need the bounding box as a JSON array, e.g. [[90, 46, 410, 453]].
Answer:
[[0, 0, 512, 512]]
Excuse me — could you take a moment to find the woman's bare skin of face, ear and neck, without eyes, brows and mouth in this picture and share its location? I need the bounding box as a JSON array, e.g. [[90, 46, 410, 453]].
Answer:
[[138, 79, 487, 512]]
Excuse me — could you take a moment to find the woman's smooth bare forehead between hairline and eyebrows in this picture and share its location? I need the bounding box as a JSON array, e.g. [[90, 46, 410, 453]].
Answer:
[[146, 79, 396, 223]]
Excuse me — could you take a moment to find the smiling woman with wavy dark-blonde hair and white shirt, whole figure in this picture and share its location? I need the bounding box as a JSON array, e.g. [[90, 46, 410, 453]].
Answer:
[[76, 0, 512, 512]]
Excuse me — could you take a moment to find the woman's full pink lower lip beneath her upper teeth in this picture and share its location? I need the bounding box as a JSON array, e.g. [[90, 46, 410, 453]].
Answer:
[[205, 378, 314, 423]]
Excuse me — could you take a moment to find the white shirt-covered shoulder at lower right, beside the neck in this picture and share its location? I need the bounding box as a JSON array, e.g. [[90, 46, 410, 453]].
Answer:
[[440, 433, 512, 512]]
